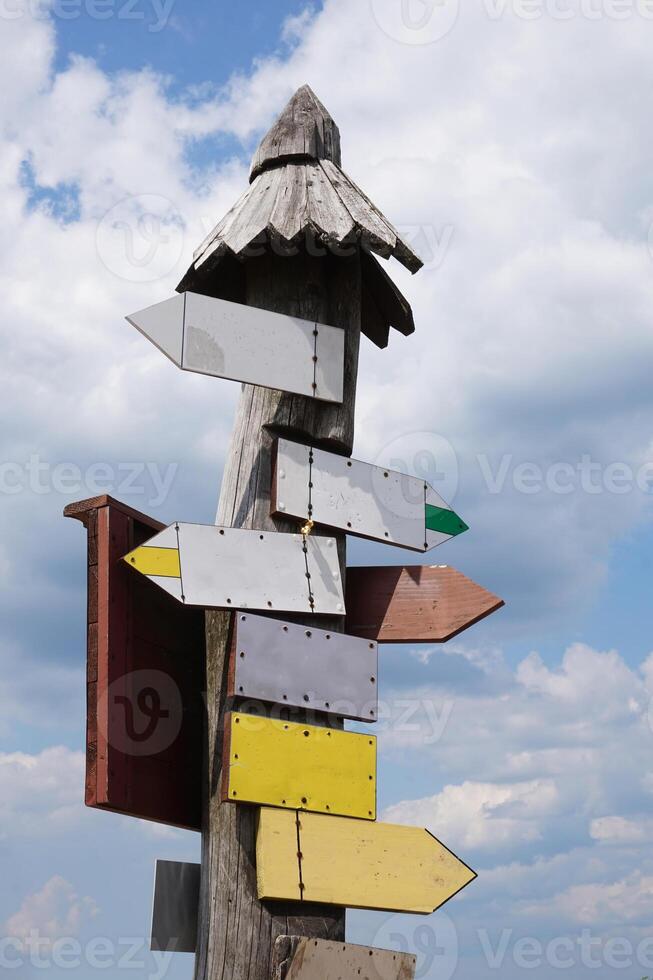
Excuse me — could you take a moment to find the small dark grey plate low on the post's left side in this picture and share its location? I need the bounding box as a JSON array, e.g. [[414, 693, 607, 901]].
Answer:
[[150, 861, 201, 953]]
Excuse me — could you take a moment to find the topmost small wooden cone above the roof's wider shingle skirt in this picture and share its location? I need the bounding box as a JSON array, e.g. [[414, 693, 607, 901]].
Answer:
[[249, 85, 341, 183]]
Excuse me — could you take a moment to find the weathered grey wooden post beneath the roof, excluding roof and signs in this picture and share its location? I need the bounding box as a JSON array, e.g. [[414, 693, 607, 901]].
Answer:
[[195, 243, 361, 980]]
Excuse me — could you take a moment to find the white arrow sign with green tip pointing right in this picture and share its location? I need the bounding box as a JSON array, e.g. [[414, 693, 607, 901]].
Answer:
[[271, 439, 468, 551]]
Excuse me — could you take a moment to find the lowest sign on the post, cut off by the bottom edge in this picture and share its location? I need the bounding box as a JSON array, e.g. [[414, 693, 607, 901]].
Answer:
[[272, 936, 417, 980]]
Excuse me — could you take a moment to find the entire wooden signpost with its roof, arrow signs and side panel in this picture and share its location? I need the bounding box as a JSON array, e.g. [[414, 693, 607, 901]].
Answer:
[[67, 86, 502, 980]]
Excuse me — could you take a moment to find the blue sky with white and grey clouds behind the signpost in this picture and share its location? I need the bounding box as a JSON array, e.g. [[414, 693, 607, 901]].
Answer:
[[0, 0, 653, 980]]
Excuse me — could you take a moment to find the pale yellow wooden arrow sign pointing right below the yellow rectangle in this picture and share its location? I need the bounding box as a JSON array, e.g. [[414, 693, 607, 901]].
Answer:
[[256, 808, 476, 914]]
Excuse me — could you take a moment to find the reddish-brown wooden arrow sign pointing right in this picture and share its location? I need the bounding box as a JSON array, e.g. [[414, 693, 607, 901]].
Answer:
[[346, 565, 504, 643]]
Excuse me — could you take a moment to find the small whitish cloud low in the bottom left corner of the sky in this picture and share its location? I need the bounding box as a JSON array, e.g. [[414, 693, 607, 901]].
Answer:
[[4, 876, 99, 942]]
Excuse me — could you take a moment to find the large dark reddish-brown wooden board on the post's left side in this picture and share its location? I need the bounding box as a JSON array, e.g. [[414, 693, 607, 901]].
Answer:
[[64, 496, 205, 830]]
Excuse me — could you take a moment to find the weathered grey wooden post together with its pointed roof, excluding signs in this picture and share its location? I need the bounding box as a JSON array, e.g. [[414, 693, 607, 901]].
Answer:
[[179, 86, 421, 980]]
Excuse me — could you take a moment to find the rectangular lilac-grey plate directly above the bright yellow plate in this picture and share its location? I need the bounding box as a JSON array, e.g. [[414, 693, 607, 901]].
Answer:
[[228, 613, 378, 722]]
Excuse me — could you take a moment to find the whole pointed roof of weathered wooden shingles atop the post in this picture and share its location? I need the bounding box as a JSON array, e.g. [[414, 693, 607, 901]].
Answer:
[[177, 85, 423, 347]]
